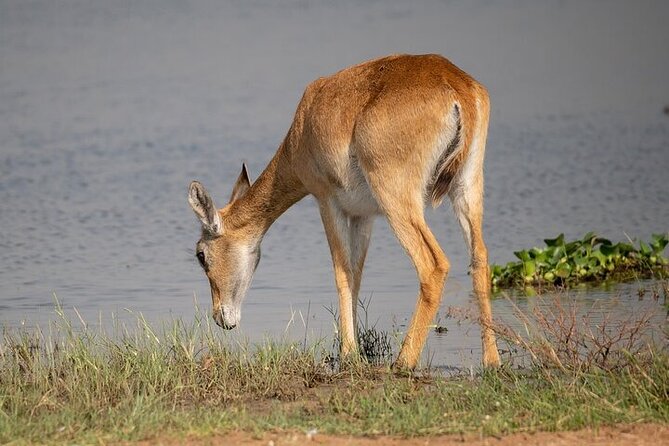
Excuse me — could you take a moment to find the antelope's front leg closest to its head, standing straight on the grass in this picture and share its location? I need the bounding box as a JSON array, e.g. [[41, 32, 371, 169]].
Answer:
[[319, 200, 364, 356]]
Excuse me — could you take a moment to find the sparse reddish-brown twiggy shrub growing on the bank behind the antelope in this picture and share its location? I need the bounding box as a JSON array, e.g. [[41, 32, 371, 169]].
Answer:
[[496, 286, 669, 373]]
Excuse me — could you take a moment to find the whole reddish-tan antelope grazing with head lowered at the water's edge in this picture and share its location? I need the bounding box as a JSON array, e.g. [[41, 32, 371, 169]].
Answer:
[[188, 55, 500, 369]]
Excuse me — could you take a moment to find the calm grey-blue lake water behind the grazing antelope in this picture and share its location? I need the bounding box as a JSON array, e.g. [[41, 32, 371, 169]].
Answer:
[[0, 0, 669, 366]]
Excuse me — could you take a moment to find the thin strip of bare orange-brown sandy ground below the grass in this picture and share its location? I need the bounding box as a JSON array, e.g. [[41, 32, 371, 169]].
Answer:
[[141, 424, 669, 446]]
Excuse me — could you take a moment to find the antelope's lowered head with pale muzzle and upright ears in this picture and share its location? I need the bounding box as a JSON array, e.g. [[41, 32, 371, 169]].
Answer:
[[188, 165, 260, 330]]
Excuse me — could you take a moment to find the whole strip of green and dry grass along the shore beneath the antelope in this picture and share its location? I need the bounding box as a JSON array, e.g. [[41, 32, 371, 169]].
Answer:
[[0, 294, 669, 443]]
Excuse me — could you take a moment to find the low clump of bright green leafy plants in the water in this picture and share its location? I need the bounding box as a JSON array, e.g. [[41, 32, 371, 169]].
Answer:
[[491, 232, 669, 290]]
